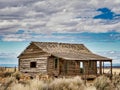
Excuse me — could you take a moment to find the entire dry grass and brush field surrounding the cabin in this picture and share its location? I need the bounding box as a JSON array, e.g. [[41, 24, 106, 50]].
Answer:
[[0, 68, 120, 90]]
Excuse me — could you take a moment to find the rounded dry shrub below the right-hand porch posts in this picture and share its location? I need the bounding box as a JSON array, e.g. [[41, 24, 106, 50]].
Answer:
[[94, 76, 113, 90]]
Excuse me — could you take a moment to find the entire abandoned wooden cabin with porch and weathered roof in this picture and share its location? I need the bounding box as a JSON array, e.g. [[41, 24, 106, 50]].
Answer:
[[18, 42, 112, 76]]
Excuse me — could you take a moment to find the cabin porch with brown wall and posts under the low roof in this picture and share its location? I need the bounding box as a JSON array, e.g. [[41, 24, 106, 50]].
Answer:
[[54, 59, 112, 77]]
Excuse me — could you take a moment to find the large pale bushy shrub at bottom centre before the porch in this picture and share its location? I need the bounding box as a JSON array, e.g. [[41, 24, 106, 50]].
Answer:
[[49, 77, 85, 90]]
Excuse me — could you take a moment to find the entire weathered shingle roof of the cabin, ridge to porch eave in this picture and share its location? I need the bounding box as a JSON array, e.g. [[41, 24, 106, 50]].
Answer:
[[31, 42, 111, 60]]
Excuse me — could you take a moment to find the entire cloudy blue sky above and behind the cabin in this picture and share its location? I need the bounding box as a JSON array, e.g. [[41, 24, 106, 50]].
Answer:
[[0, 0, 120, 65]]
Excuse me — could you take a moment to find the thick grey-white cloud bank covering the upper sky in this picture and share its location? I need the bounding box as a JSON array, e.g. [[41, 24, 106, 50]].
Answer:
[[0, 0, 120, 41]]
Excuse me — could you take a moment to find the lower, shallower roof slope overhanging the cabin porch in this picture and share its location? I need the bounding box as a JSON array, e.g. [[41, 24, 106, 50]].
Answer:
[[52, 52, 112, 61]]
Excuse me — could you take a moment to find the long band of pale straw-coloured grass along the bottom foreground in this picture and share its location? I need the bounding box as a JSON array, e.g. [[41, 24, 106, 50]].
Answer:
[[11, 77, 86, 90]]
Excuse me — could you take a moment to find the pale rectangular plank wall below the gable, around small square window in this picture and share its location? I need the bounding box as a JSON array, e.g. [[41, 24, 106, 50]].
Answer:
[[20, 57, 47, 73]]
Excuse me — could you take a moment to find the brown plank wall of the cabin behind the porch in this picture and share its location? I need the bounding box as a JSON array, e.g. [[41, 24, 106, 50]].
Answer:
[[59, 60, 97, 75]]
